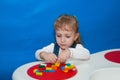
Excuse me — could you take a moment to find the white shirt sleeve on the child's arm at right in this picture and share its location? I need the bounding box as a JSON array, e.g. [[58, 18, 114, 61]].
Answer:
[[69, 44, 90, 60]]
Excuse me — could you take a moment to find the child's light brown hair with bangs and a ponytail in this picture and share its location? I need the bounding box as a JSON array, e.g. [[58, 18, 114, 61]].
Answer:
[[54, 14, 82, 43]]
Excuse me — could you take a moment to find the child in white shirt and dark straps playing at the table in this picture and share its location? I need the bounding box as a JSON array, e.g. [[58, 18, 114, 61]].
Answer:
[[35, 15, 90, 63]]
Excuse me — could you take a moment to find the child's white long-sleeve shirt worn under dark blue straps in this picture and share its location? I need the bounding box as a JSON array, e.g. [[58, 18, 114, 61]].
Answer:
[[35, 43, 90, 60]]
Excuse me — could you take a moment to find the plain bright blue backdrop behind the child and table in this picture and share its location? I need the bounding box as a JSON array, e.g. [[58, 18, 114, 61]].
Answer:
[[0, 0, 120, 80]]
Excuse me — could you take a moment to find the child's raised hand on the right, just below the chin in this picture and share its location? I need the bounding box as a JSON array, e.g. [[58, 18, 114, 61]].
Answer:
[[57, 49, 70, 63]]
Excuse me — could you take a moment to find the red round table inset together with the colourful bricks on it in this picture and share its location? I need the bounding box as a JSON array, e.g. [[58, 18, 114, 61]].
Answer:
[[27, 62, 78, 80]]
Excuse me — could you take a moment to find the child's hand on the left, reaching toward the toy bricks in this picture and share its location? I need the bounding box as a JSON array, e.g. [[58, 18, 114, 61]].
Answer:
[[41, 52, 57, 63]]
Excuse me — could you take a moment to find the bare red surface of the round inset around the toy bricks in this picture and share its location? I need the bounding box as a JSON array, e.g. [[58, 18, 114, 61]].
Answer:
[[27, 63, 77, 80]]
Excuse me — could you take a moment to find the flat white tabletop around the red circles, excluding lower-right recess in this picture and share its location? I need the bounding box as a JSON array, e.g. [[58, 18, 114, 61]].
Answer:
[[12, 49, 120, 80]]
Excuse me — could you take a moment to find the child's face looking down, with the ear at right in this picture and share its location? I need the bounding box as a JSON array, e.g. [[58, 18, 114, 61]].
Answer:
[[56, 29, 79, 49]]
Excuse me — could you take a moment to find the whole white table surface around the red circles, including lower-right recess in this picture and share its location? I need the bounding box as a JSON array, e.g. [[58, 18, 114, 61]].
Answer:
[[12, 49, 120, 80]]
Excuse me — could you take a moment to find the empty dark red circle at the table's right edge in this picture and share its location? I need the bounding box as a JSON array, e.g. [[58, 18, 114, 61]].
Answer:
[[105, 51, 120, 64]]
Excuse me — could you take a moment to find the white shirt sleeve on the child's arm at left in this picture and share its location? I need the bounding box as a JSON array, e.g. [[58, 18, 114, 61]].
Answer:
[[35, 43, 54, 60]]
